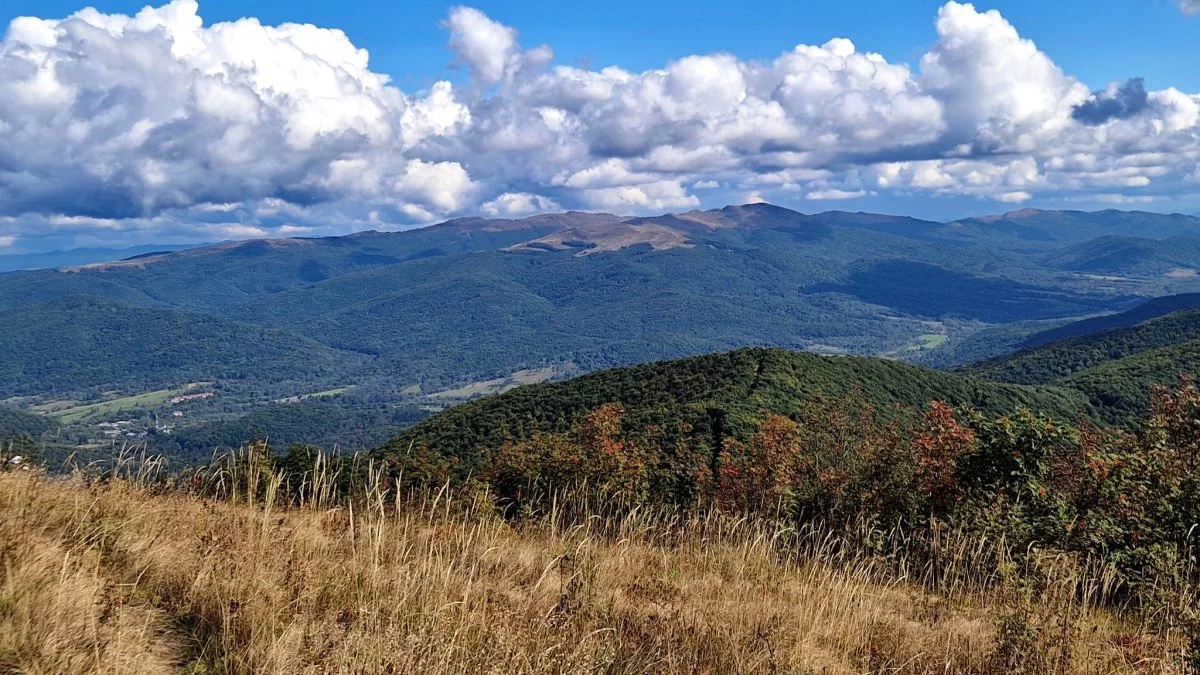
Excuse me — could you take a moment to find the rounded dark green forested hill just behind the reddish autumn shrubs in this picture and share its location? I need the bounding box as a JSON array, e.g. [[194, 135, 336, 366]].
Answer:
[[378, 350, 1088, 466]]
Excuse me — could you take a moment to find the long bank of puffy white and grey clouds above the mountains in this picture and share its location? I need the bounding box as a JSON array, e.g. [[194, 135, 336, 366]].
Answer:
[[0, 0, 1200, 245]]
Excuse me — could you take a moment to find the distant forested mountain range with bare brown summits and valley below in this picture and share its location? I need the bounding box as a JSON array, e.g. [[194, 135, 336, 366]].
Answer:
[[7, 204, 1200, 451]]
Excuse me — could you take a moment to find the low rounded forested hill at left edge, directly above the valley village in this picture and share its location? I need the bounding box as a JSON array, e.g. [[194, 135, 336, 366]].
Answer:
[[0, 297, 366, 398]]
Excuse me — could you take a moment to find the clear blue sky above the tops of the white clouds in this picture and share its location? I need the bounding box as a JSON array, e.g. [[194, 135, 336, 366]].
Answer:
[[0, 0, 1200, 91]]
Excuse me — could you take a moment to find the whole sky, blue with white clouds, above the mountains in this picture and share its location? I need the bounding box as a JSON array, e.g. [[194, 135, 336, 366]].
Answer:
[[0, 0, 1200, 249]]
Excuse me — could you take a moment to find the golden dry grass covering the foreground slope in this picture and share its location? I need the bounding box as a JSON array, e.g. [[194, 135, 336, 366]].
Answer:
[[0, 471, 1181, 673]]
